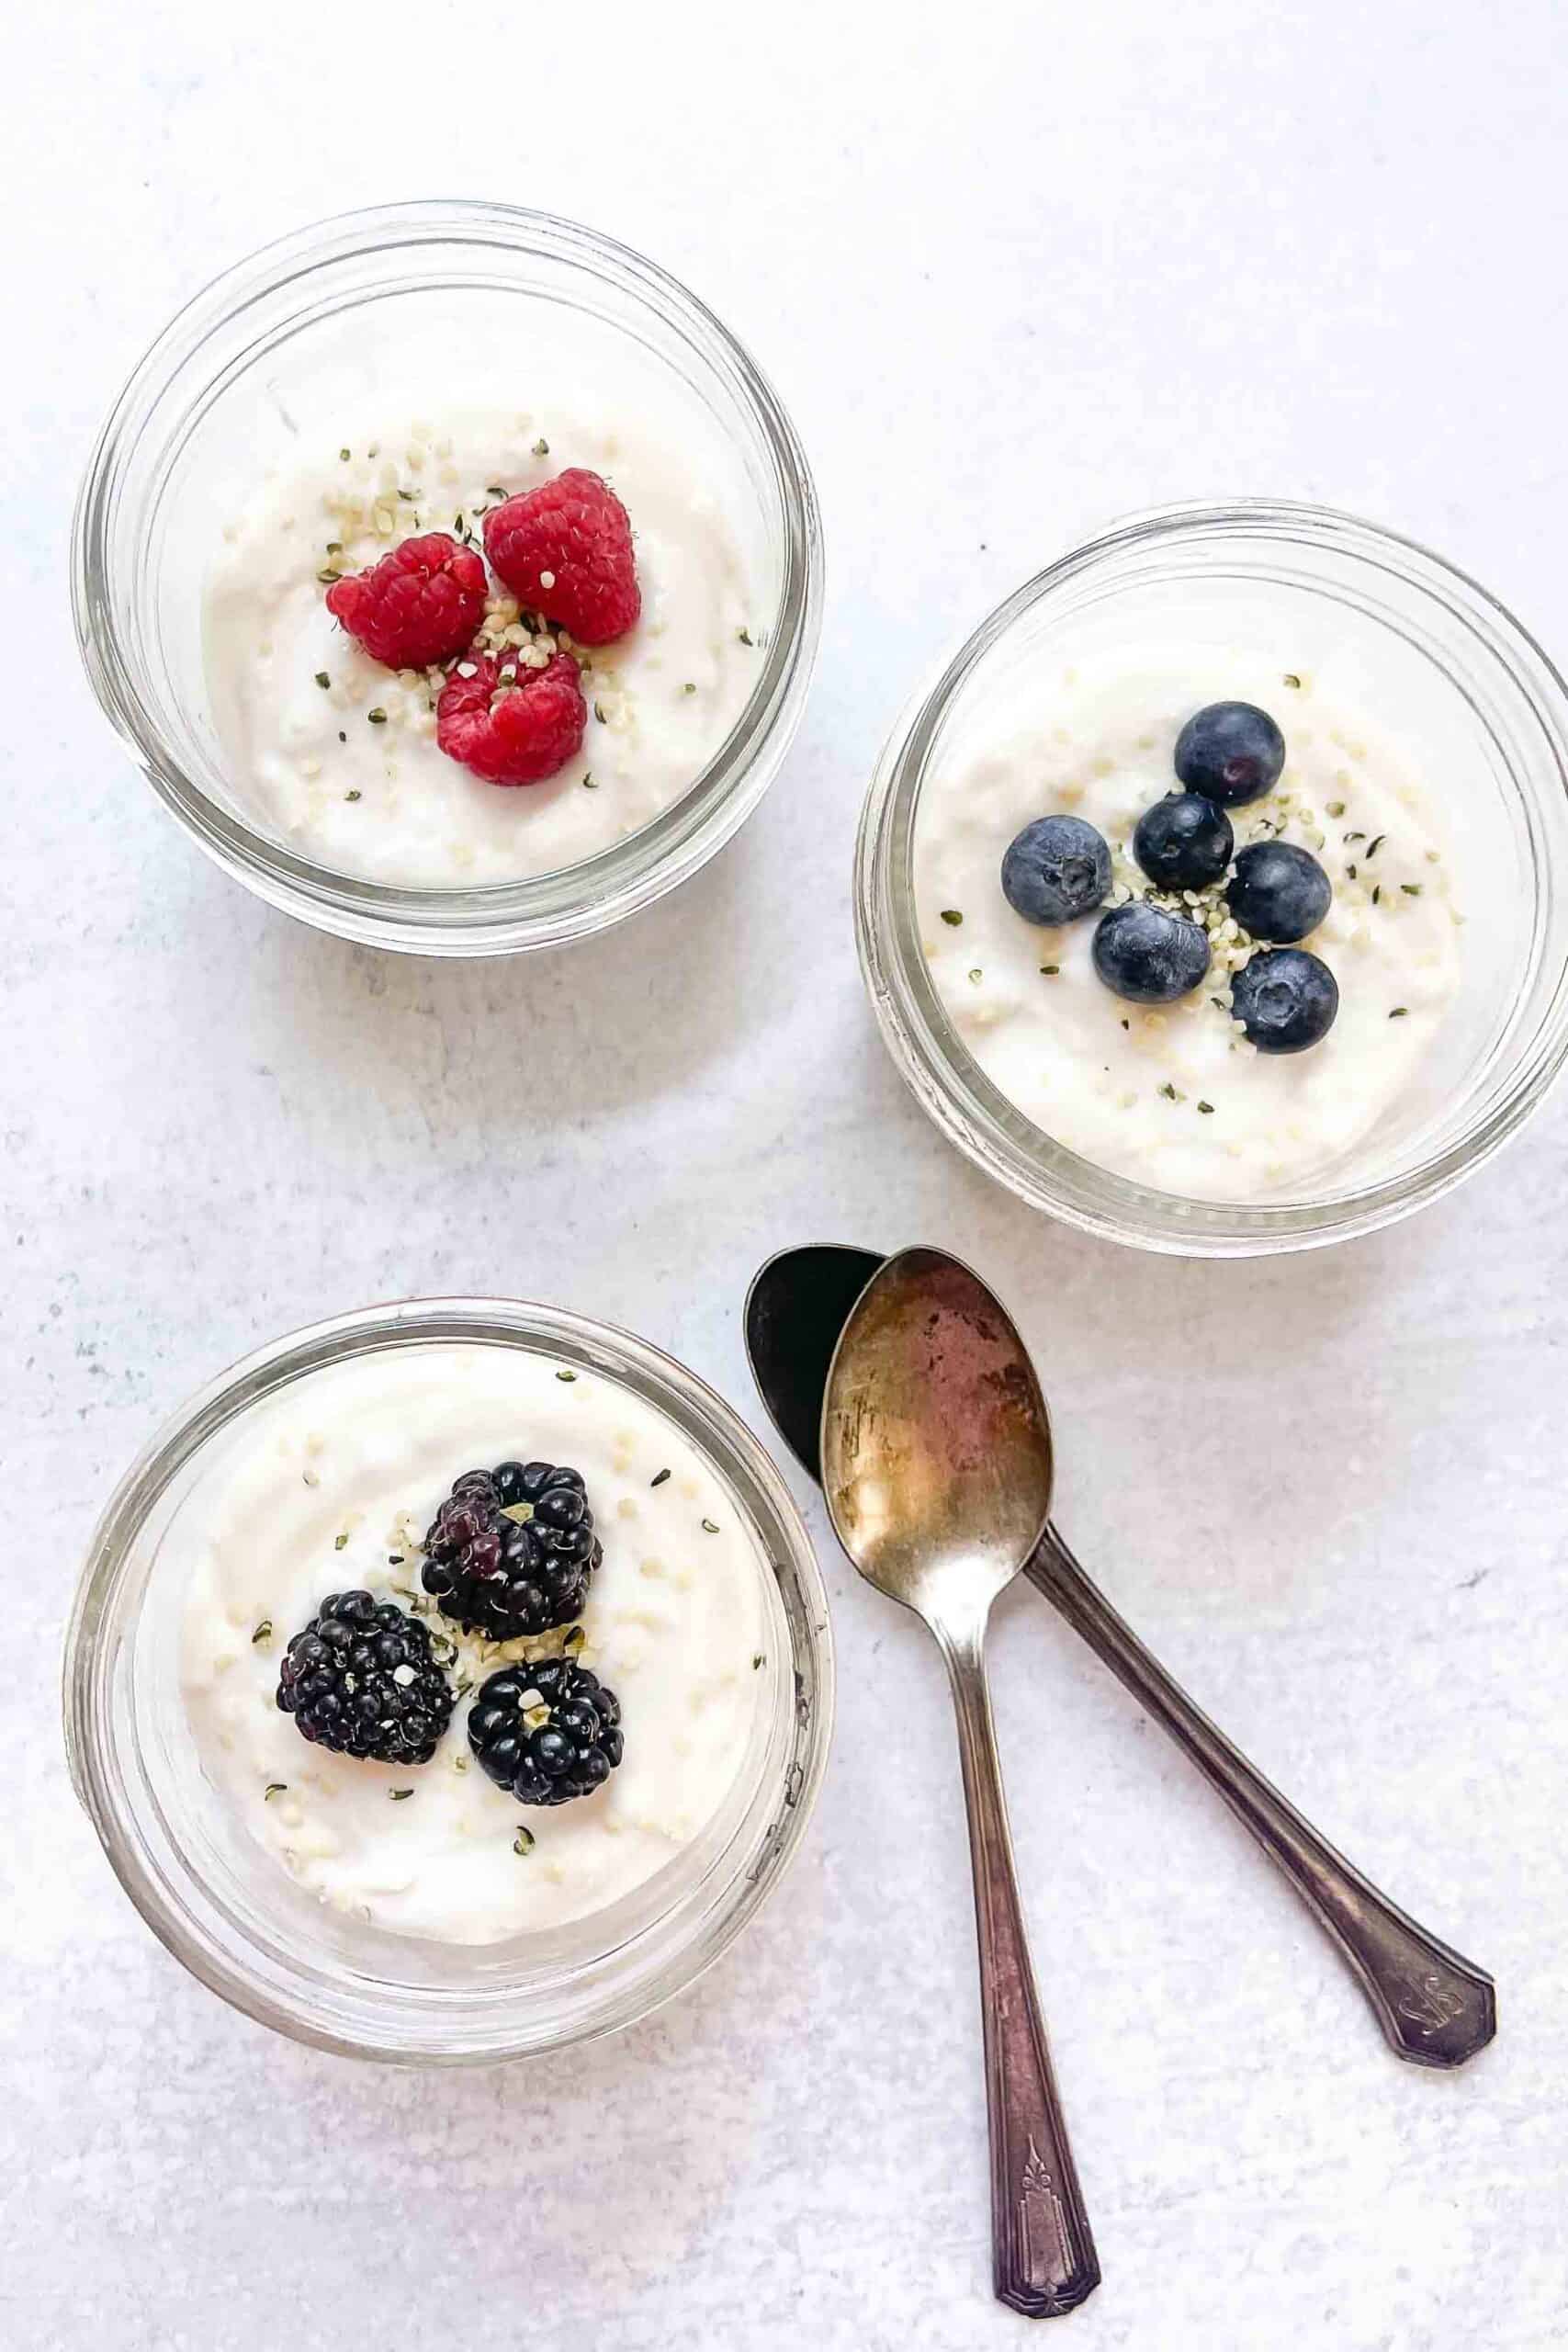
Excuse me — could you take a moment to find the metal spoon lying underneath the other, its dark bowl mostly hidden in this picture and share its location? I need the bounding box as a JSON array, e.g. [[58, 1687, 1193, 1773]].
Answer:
[[745, 1244, 1497, 2067]]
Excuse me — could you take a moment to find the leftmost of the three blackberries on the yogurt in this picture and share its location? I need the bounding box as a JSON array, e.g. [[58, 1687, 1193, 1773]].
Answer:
[[277, 1592, 451, 1764]]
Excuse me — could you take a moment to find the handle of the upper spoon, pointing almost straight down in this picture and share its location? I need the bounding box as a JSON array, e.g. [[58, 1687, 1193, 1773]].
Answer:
[[938, 1623, 1100, 2319]]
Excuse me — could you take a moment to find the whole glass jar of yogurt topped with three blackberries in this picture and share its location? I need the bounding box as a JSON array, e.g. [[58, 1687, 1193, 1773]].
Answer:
[[66, 1301, 832, 2058]]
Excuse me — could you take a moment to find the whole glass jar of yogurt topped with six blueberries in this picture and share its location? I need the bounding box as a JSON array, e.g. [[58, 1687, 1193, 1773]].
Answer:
[[856, 499, 1568, 1256]]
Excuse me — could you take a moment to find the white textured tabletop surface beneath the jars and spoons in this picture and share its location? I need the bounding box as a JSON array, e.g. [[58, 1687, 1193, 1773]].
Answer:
[[0, 0, 1568, 2352]]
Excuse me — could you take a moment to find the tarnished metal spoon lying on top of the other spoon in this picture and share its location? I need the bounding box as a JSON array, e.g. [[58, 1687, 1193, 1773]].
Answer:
[[820, 1249, 1100, 2319]]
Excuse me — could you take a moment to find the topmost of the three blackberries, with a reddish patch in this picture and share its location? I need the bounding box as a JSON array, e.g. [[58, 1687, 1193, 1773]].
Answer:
[[423, 1463, 604, 1642]]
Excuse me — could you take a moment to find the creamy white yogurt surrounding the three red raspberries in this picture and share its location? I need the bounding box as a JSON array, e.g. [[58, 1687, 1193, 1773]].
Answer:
[[202, 407, 761, 889]]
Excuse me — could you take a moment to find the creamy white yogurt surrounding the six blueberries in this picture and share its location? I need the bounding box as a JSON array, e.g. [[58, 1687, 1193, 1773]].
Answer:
[[915, 650, 1462, 1200]]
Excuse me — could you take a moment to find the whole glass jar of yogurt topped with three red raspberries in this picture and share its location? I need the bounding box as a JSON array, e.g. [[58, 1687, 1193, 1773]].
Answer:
[[73, 202, 823, 955]]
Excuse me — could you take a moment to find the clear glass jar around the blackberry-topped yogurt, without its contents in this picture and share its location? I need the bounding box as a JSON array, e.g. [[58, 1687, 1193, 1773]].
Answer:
[[63, 1298, 832, 2063]]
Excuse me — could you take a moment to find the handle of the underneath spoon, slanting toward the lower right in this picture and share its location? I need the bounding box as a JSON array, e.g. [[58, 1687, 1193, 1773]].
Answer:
[[1025, 1526, 1497, 2067]]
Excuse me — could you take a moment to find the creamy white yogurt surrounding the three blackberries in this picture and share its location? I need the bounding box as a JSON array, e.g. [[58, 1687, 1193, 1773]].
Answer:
[[181, 1343, 771, 1943]]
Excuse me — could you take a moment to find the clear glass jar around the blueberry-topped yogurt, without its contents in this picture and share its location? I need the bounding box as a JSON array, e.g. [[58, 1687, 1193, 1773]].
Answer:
[[856, 499, 1568, 1259]]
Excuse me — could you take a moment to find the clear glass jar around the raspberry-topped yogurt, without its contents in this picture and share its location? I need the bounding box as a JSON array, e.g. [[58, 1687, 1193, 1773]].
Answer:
[[73, 202, 823, 955]]
